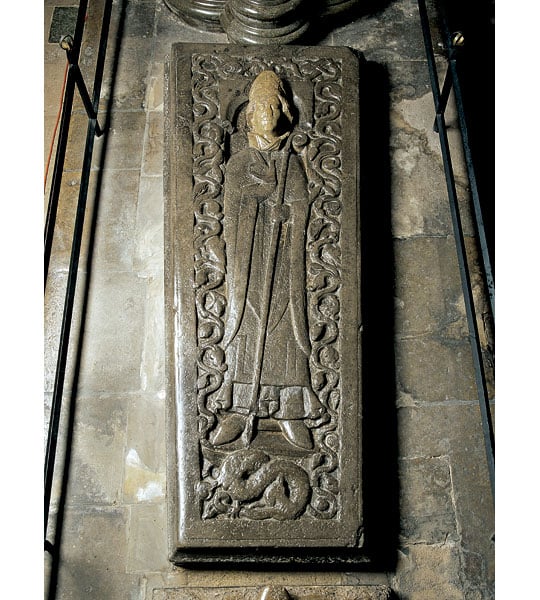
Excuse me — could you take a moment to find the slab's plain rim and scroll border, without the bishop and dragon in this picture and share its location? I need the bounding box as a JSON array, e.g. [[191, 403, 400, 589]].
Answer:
[[164, 44, 360, 564]]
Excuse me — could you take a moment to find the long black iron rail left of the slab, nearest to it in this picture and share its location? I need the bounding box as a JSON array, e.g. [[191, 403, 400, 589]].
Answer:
[[45, 0, 112, 537]]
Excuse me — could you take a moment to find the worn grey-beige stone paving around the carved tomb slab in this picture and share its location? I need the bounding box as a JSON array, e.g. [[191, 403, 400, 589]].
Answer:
[[45, 0, 494, 600]]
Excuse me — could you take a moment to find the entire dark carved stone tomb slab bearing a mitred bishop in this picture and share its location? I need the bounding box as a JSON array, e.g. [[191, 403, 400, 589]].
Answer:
[[165, 44, 365, 564]]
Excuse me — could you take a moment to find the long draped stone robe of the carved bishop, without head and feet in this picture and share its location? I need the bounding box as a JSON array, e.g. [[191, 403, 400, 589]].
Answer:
[[218, 147, 324, 419]]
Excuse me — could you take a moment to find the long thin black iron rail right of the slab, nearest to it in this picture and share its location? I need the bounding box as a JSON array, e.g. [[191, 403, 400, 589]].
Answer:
[[418, 0, 495, 496]]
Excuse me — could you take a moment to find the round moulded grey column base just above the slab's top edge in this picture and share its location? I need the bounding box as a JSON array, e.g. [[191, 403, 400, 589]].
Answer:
[[221, 0, 309, 44]]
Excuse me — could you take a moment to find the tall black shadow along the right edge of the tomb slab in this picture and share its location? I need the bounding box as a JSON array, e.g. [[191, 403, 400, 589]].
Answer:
[[360, 61, 399, 571]]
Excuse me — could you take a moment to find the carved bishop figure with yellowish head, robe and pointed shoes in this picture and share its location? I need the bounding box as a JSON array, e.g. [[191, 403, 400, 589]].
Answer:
[[210, 71, 324, 449]]
